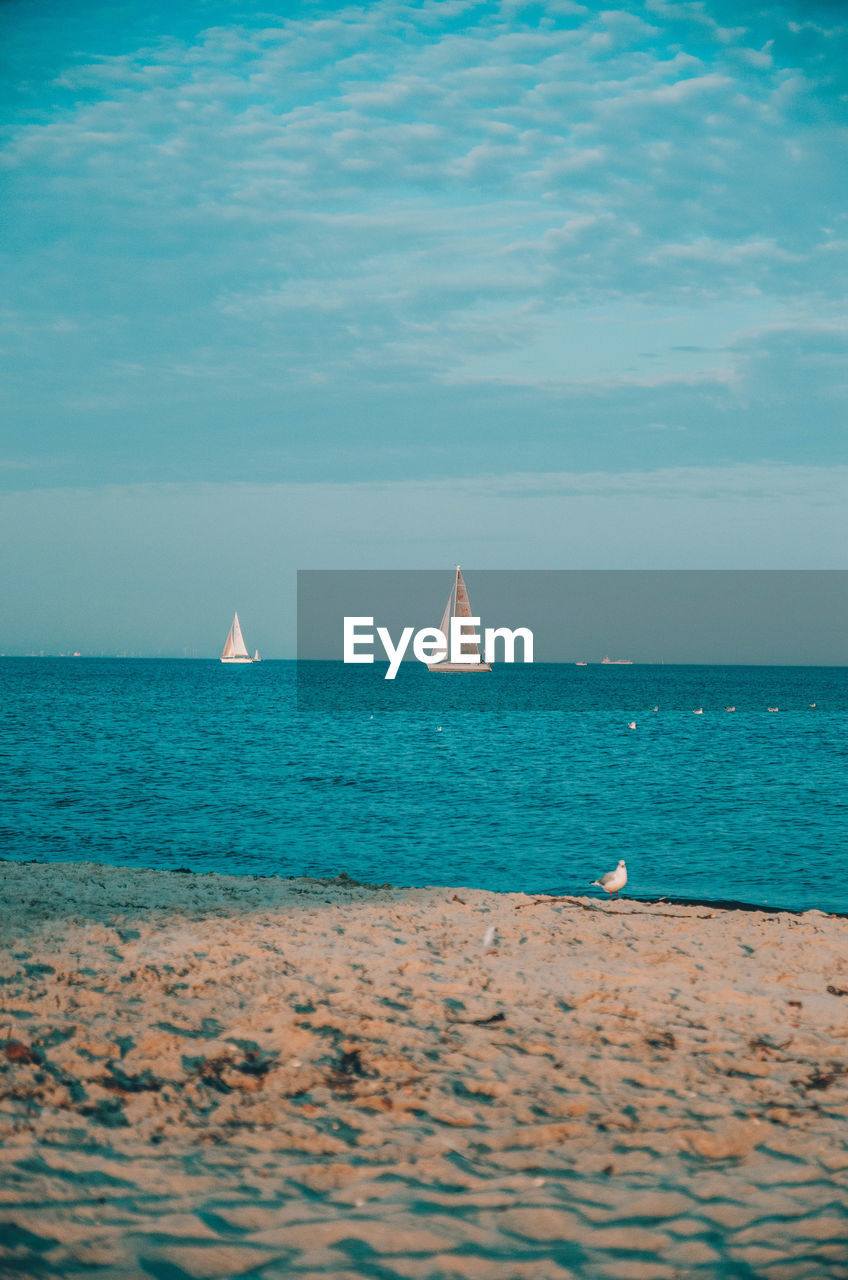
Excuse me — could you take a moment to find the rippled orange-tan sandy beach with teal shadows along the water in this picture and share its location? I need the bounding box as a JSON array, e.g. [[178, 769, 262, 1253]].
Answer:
[[0, 863, 848, 1280]]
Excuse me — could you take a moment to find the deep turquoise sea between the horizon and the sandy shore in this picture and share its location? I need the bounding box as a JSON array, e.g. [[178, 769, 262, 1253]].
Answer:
[[0, 658, 848, 913]]
